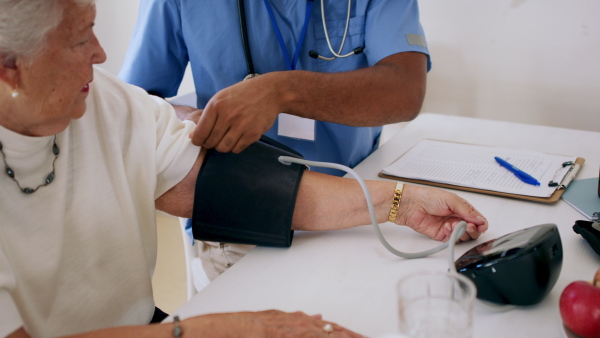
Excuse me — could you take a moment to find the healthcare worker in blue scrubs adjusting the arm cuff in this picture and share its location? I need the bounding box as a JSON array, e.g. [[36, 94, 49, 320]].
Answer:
[[119, 0, 430, 279]]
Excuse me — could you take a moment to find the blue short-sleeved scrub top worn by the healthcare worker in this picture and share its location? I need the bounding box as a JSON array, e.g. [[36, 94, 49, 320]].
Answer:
[[119, 0, 430, 176]]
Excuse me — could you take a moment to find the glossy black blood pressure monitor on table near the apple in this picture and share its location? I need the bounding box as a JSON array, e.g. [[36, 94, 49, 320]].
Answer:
[[455, 224, 563, 305]]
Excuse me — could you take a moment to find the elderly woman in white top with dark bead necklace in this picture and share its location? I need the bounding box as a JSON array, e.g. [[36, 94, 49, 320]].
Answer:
[[0, 0, 487, 337]]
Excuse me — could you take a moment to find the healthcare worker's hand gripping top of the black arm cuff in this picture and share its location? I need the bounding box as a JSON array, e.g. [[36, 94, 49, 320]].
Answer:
[[192, 74, 281, 153]]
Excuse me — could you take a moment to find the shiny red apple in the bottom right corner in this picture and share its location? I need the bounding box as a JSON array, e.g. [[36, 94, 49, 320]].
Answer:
[[559, 269, 600, 338]]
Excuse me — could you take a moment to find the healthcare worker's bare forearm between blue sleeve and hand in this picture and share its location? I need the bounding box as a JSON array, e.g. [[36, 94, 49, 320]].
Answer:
[[265, 52, 427, 126]]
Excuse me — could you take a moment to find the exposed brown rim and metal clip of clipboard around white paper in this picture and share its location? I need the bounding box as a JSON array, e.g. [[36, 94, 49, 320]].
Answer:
[[378, 140, 585, 204]]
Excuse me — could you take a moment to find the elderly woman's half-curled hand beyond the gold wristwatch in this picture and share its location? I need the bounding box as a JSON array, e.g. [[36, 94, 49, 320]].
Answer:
[[396, 185, 488, 242]]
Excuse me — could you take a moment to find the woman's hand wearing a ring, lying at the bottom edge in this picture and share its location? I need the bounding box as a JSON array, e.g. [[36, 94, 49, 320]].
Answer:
[[186, 310, 362, 338]]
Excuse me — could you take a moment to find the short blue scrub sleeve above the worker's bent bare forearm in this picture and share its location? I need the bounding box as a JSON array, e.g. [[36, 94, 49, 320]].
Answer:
[[365, 0, 431, 70]]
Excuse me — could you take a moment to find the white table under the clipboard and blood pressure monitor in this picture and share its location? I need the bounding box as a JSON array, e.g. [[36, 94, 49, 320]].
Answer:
[[171, 113, 600, 338]]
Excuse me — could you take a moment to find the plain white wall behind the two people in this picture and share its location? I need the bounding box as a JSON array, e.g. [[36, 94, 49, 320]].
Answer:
[[96, 0, 600, 131]]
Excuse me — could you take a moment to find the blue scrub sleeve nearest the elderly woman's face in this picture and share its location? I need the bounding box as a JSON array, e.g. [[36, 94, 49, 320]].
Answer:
[[119, 0, 189, 97]]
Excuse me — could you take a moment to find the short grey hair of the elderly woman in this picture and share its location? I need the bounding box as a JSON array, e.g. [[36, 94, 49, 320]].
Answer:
[[0, 0, 95, 61]]
